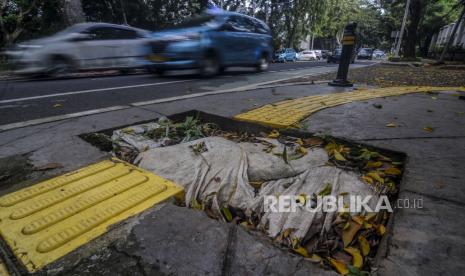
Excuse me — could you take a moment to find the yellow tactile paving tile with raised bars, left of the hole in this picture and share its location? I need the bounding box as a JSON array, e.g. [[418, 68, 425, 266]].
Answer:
[[0, 159, 183, 274]]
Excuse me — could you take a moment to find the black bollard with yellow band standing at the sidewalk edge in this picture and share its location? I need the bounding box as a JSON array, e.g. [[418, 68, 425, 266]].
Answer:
[[329, 22, 357, 87]]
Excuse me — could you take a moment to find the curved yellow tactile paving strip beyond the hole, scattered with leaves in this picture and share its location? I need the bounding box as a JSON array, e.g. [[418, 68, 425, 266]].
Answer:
[[234, 86, 465, 128]]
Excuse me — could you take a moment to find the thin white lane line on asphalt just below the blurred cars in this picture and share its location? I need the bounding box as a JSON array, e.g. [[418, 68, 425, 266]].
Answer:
[[0, 80, 191, 104]]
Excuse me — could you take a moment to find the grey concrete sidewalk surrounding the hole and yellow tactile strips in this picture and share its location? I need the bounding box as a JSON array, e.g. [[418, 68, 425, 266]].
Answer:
[[0, 85, 465, 275]]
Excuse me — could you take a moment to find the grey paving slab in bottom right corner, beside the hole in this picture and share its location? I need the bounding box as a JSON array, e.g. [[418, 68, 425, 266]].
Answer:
[[378, 192, 465, 276]]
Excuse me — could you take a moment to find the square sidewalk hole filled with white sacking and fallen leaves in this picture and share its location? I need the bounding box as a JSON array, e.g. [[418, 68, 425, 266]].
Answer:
[[81, 111, 406, 275]]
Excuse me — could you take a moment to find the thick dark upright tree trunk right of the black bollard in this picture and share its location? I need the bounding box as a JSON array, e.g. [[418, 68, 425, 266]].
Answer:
[[404, 0, 425, 58]]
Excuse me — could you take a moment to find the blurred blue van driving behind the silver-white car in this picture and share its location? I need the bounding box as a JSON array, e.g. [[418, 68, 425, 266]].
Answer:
[[147, 11, 273, 76]]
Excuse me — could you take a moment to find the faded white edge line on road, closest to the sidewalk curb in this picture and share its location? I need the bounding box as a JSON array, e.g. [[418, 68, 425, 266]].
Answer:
[[0, 105, 131, 132]]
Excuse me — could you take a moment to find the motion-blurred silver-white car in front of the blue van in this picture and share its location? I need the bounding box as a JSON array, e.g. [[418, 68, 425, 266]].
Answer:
[[5, 23, 148, 76]]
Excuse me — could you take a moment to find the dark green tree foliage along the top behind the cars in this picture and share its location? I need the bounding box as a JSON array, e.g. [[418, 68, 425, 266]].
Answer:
[[0, 0, 459, 55]]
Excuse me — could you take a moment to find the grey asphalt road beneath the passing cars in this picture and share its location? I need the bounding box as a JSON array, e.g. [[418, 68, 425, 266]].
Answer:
[[0, 62, 336, 125]]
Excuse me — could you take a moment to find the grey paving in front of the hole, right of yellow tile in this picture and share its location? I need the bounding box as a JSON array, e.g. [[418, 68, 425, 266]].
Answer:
[[61, 203, 337, 275]]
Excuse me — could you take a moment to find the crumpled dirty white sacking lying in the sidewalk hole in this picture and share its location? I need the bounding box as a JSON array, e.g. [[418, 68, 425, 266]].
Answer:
[[136, 137, 374, 238]]
